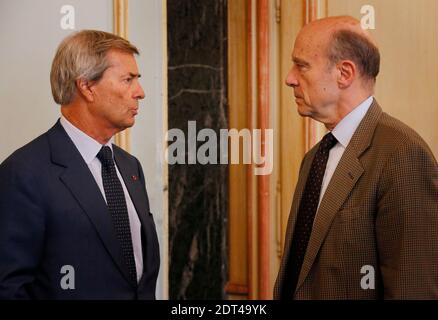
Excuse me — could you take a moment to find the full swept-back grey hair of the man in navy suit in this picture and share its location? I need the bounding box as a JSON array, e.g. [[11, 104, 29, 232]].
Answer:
[[50, 30, 139, 105]]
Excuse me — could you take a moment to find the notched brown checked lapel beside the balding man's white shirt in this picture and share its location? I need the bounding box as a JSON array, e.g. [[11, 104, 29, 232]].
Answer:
[[291, 99, 382, 290]]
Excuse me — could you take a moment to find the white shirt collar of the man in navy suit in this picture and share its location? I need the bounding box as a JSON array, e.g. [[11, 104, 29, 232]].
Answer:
[[60, 116, 114, 165]]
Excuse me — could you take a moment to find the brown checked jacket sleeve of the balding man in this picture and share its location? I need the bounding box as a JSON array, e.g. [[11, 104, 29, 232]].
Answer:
[[376, 141, 438, 299]]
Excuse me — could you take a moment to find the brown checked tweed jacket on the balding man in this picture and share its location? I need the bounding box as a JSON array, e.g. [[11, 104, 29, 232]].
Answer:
[[274, 100, 438, 299]]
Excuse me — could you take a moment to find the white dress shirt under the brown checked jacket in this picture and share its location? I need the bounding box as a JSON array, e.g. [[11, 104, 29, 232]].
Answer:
[[318, 96, 373, 207]]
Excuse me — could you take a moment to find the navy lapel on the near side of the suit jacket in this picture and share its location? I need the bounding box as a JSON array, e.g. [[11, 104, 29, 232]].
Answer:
[[48, 121, 134, 281]]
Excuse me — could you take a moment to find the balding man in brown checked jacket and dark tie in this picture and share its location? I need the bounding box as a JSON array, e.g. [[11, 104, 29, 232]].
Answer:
[[274, 17, 438, 299]]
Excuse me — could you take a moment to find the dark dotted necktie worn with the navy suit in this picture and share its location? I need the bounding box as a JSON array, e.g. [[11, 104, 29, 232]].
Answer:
[[97, 146, 137, 283]]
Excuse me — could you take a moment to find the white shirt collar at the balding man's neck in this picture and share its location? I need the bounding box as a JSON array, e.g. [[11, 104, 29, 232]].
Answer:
[[332, 96, 373, 148]]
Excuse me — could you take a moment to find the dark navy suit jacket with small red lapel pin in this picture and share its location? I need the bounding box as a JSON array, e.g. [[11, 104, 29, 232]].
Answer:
[[0, 121, 160, 299]]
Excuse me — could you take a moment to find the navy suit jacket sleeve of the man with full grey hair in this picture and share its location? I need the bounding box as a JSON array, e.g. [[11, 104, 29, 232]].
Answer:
[[0, 158, 45, 299]]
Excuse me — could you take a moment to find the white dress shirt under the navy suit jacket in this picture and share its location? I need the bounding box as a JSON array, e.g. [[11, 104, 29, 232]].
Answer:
[[60, 116, 143, 282]]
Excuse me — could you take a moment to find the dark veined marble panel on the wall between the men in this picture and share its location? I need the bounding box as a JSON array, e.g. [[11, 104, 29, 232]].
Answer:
[[167, 0, 228, 299]]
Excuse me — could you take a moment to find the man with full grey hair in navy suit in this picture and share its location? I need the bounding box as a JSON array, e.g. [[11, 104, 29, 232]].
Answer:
[[0, 30, 160, 299]]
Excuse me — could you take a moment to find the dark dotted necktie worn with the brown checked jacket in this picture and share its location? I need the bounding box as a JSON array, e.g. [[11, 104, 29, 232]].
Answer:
[[280, 133, 337, 299]]
